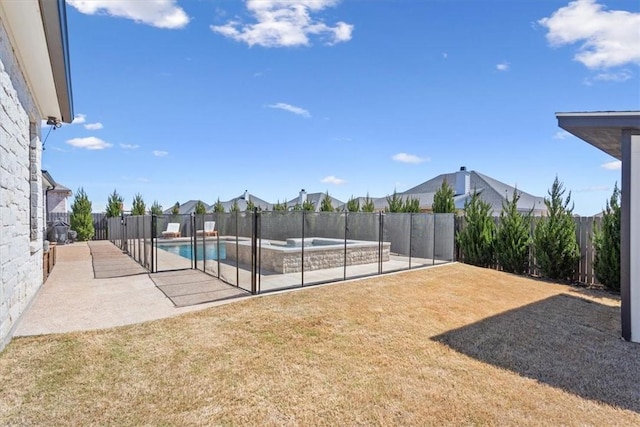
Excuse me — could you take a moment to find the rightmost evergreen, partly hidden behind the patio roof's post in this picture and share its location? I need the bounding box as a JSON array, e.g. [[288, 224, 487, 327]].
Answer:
[[593, 184, 621, 292]]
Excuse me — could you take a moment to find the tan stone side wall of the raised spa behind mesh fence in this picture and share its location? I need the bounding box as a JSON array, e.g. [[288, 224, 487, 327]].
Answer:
[[225, 241, 391, 274]]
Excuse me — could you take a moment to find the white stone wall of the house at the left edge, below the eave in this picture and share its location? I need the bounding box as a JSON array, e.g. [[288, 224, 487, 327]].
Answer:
[[0, 22, 44, 350]]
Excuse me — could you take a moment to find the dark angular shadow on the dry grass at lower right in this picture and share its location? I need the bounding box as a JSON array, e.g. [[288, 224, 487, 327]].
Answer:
[[432, 295, 640, 412]]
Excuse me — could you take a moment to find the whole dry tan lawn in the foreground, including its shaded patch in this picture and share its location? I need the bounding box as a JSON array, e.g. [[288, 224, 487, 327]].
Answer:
[[0, 264, 640, 425]]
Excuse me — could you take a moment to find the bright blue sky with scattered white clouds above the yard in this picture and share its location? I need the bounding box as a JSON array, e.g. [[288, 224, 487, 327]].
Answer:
[[42, 0, 640, 215]]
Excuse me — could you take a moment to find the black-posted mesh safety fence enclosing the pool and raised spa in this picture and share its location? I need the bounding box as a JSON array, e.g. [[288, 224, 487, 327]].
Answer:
[[108, 211, 455, 294]]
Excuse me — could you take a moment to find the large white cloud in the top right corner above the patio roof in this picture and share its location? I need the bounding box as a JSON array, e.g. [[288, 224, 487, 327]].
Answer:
[[538, 0, 640, 68]]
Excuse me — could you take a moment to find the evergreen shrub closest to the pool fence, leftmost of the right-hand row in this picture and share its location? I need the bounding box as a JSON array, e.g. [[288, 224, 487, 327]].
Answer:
[[456, 191, 496, 267]]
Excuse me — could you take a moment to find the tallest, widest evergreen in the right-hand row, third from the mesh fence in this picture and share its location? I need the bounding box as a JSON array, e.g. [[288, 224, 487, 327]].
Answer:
[[534, 176, 580, 280]]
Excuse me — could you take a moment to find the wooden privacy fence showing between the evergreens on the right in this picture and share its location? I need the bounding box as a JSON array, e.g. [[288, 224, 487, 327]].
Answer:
[[456, 216, 602, 285]]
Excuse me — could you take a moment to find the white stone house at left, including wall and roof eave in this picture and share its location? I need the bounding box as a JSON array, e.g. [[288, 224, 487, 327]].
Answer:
[[0, 0, 73, 350]]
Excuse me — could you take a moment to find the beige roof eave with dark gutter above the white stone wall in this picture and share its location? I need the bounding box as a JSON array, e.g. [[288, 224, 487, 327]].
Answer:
[[0, 0, 73, 123]]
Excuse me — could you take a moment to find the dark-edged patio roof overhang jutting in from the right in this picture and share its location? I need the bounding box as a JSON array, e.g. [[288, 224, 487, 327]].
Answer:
[[556, 111, 640, 160]]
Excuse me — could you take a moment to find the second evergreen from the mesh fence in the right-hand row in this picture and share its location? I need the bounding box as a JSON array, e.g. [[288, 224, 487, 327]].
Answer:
[[495, 189, 532, 274]]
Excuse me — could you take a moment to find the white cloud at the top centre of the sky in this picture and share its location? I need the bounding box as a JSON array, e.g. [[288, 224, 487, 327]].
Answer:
[[210, 0, 353, 47]]
